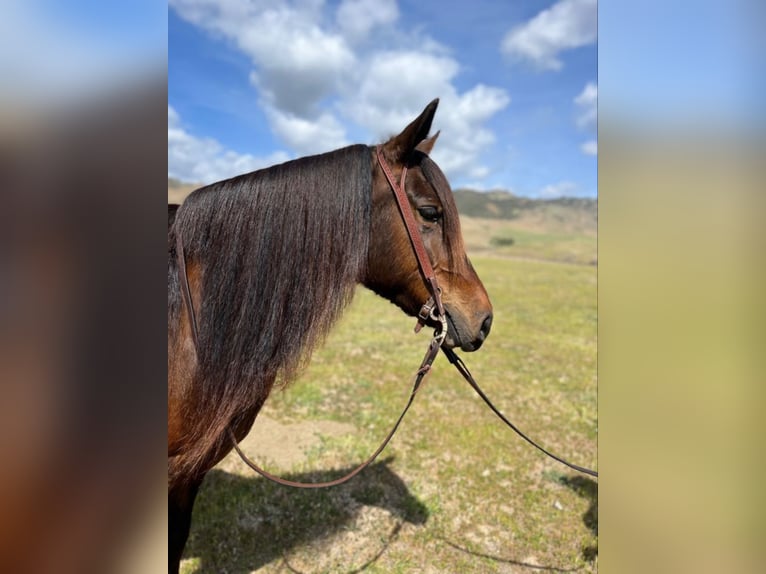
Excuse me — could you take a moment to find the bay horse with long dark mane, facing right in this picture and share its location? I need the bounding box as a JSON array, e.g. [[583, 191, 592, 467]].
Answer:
[[168, 99, 492, 572]]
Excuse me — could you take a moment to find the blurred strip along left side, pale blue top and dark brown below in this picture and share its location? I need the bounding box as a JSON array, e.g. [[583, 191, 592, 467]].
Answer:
[[0, 1, 167, 574]]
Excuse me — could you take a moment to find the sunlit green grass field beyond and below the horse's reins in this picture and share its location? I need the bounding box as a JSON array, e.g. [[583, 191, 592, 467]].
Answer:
[[183, 242, 598, 574]]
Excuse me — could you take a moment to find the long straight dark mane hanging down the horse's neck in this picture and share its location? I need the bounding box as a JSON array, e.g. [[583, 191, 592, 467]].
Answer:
[[168, 145, 372, 480]]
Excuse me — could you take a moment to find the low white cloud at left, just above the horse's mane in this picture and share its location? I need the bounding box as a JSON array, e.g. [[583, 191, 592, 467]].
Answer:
[[168, 106, 288, 183]]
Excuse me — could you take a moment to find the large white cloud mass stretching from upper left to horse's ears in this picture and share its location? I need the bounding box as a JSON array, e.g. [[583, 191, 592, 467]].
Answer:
[[170, 0, 510, 184]]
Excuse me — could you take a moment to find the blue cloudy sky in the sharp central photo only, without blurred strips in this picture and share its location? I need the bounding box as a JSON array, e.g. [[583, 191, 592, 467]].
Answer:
[[168, 0, 598, 197]]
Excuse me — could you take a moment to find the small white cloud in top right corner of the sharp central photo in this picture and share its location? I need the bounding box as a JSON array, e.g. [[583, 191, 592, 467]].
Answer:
[[501, 0, 598, 70]]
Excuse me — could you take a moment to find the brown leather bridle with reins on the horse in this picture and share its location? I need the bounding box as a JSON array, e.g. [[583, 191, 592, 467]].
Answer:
[[176, 146, 598, 488]]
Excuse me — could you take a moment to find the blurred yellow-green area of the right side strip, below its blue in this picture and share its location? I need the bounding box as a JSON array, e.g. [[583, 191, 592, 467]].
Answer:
[[598, 130, 766, 573]]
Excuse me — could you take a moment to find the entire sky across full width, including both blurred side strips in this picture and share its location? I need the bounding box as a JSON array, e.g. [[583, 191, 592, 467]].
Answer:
[[0, 0, 766, 201]]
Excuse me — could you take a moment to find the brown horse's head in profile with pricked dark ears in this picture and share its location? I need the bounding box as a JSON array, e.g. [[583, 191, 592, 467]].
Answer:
[[362, 100, 492, 351]]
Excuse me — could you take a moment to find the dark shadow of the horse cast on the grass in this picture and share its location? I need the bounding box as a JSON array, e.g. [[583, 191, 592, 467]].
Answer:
[[183, 458, 428, 574]]
